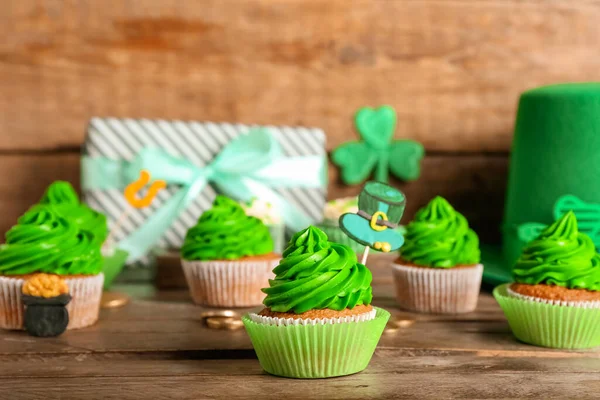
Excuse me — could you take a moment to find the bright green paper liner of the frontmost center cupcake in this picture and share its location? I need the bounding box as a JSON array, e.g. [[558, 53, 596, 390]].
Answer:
[[242, 307, 390, 378]]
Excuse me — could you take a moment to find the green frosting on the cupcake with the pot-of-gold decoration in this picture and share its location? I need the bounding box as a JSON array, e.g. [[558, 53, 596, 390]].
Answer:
[[0, 204, 102, 275]]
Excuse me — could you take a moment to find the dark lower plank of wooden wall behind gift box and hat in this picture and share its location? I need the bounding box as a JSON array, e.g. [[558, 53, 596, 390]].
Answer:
[[0, 152, 508, 242]]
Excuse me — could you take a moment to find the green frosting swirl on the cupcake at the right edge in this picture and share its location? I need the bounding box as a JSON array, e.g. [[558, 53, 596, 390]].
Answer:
[[513, 211, 600, 291]]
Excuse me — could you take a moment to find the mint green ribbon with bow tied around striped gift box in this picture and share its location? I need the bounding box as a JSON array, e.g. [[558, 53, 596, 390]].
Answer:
[[81, 129, 327, 262]]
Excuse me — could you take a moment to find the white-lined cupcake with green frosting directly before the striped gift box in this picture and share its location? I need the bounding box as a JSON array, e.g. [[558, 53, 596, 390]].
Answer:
[[181, 196, 281, 307]]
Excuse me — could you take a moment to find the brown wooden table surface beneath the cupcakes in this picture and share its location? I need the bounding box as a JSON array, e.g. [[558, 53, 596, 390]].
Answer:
[[0, 258, 600, 400]]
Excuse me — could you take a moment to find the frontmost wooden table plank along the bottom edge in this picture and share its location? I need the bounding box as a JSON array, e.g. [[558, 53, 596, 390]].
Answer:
[[0, 368, 600, 400]]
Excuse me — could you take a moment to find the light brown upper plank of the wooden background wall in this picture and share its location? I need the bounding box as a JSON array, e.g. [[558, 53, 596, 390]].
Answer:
[[0, 0, 600, 152]]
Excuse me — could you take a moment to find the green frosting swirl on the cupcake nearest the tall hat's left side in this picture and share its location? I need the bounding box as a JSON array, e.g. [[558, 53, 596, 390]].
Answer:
[[400, 196, 481, 268]]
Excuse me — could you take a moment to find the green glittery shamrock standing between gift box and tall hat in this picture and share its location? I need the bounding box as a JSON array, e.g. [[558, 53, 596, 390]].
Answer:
[[332, 106, 425, 185]]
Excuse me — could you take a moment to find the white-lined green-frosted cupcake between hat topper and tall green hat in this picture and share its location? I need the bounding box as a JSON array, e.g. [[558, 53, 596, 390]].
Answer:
[[392, 196, 483, 314]]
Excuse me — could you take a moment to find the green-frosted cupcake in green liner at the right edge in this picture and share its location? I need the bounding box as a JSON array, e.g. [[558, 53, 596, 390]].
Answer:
[[494, 211, 600, 349]]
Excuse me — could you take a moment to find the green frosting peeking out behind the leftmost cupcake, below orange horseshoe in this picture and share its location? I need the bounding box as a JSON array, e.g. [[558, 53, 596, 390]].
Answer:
[[40, 181, 108, 244]]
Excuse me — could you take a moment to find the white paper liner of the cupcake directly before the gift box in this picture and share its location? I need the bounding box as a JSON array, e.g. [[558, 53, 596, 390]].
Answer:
[[181, 259, 279, 307]]
